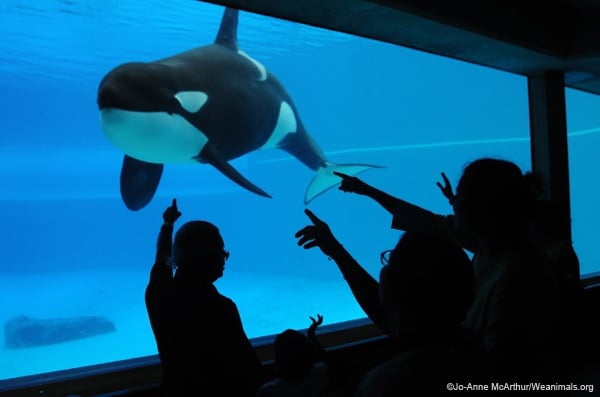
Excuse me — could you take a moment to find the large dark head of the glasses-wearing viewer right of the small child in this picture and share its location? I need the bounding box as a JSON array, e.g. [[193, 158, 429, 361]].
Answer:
[[379, 231, 475, 346]]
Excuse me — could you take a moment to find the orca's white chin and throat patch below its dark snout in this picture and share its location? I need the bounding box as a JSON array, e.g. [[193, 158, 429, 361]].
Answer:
[[100, 108, 208, 164]]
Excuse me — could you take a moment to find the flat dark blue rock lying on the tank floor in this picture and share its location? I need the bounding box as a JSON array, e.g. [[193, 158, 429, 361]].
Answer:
[[4, 315, 116, 349]]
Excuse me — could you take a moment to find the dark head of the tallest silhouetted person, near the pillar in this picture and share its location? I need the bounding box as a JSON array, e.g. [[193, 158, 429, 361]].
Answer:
[[453, 158, 538, 242]]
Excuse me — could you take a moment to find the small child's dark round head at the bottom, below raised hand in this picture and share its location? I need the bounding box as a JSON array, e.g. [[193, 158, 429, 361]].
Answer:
[[273, 329, 316, 379]]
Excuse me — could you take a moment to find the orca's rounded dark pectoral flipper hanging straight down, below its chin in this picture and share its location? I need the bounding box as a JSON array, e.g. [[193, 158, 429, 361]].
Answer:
[[121, 155, 163, 211]]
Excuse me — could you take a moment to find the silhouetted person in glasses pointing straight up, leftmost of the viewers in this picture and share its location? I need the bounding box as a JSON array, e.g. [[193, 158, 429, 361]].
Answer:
[[145, 199, 265, 396]]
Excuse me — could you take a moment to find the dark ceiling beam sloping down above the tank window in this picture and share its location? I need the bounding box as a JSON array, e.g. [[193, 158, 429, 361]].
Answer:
[[206, 0, 600, 94]]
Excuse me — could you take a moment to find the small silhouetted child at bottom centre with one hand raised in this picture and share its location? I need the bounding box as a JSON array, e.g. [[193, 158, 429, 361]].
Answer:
[[257, 314, 329, 397]]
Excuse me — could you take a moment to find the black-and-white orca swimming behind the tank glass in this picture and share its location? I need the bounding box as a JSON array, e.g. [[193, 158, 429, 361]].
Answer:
[[97, 8, 379, 211]]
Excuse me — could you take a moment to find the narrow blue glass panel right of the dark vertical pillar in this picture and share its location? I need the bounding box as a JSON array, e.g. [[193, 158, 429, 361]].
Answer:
[[565, 89, 600, 276]]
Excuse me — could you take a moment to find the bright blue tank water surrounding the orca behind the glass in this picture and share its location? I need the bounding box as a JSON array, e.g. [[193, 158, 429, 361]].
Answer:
[[0, 0, 600, 379]]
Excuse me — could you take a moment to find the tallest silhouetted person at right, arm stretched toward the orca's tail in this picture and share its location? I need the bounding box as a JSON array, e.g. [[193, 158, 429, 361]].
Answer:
[[337, 164, 582, 381]]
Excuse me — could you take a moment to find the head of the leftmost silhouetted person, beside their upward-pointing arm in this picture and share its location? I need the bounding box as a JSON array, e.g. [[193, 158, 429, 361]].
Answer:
[[173, 221, 229, 282]]
